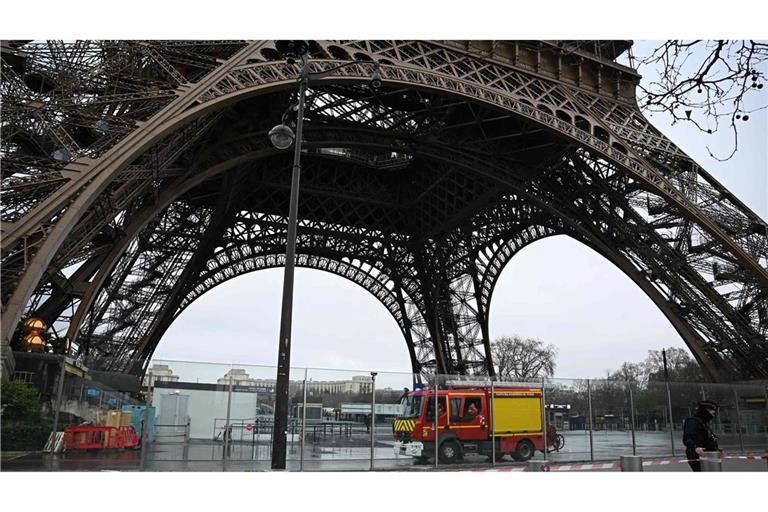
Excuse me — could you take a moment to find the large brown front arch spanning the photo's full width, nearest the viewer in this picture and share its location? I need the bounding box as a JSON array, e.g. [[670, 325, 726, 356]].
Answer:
[[4, 42, 768, 348]]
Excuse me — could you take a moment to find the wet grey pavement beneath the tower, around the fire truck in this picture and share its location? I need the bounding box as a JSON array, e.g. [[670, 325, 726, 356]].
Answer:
[[0, 427, 768, 472]]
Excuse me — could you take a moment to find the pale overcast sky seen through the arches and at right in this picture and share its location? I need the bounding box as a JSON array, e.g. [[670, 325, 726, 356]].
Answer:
[[155, 42, 768, 381]]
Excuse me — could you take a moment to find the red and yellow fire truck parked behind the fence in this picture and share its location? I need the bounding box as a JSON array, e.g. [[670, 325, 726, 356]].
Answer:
[[392, 383, 544, 463]]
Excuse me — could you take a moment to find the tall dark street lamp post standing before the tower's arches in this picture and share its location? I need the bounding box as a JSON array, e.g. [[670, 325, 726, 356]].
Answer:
[[269, 41, 381, 469]]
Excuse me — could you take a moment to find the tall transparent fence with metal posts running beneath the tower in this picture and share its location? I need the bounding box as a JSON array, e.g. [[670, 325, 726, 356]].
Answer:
[[9, 361, 768, 471]]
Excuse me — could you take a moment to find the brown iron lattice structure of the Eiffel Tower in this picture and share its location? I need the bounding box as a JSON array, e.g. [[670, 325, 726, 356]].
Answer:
[[2, 41, 768, 381]]
